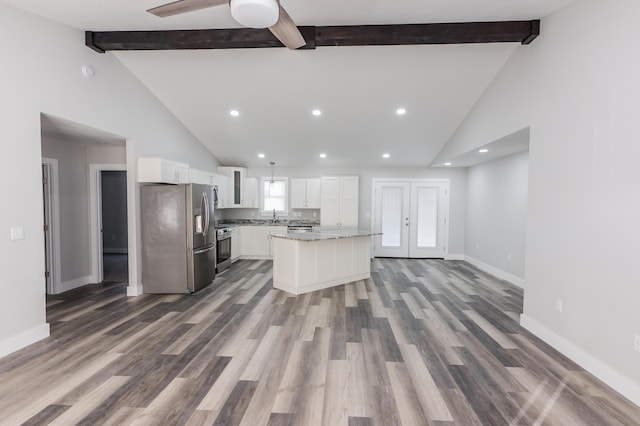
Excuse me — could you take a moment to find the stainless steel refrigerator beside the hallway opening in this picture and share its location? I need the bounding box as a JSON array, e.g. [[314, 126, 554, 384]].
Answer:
[[140, 184, 216, 293]]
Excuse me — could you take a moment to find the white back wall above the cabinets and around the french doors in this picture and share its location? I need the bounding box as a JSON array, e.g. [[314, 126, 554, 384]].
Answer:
[[242, 167, 467, 256]]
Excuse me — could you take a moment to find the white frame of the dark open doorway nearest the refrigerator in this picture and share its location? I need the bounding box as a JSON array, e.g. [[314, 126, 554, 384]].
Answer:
[[89, 164, 129, 283]]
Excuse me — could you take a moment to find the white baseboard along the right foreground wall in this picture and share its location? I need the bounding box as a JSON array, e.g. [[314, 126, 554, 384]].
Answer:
[[520, 314, 640, 406]]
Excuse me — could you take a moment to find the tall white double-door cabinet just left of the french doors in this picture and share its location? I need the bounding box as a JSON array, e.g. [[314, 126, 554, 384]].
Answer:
[[320, 176, 359, 227]]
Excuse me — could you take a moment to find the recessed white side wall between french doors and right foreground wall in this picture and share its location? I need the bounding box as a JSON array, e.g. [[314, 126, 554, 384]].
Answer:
[[465, 151, 529, 286]]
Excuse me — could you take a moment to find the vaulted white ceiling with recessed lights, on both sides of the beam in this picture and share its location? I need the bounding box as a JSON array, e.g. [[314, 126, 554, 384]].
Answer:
[[2, 0, 572, 167]]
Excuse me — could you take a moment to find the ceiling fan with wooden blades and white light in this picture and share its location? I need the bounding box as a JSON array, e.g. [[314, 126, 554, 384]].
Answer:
[[147, 0, 307, 49]]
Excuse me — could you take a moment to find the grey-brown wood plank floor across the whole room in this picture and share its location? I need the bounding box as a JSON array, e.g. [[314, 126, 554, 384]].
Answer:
[[0, 259, 640, 426]]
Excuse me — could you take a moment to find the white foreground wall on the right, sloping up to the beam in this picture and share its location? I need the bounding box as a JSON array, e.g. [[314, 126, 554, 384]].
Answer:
[[436, 0, 640, 404]]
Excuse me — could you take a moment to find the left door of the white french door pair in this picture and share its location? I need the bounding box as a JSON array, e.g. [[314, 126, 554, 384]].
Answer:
[[374, 182, 411, 257]]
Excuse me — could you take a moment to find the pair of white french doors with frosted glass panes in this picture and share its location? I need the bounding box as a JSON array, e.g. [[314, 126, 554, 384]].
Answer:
[[373, 181, 449, 258]]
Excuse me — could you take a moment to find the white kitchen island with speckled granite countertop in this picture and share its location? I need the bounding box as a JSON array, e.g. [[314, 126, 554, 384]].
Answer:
[[271, 229, 374, 295]]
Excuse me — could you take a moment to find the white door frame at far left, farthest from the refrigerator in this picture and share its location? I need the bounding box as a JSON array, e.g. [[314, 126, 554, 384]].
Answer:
[[41, 157, 62, 294]]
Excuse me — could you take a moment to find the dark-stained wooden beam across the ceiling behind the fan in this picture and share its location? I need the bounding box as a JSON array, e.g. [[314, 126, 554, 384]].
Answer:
[[85, 20, 540, 53]]
